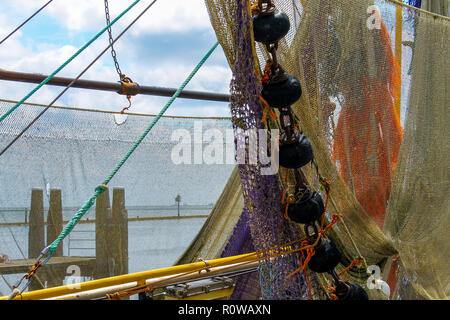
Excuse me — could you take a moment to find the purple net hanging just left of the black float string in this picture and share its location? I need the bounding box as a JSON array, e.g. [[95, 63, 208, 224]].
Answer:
[[218, 0, 315, 300]]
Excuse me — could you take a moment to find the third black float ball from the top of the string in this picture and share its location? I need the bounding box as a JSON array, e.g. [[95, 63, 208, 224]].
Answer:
[[279, 135, 314, 169]]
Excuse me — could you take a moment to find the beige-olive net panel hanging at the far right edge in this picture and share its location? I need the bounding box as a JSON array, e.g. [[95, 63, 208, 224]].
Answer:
[[385, 9, 450, 299]]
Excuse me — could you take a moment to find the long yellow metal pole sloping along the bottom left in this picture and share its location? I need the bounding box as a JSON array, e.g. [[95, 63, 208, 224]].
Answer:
[[0, 253, 258, 300]]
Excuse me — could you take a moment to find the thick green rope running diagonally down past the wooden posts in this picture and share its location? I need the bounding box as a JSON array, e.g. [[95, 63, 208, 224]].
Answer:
[[48, 42, 219, 254]]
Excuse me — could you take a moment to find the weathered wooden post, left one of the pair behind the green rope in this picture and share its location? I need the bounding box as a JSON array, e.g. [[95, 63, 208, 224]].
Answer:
[[94, 190, 113, 279]]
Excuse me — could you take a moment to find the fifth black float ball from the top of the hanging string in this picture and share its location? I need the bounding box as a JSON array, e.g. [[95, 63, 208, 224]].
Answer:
[[308, 238, 341, 273]]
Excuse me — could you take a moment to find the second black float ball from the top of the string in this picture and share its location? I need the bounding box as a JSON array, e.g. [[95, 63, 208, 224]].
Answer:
[[261, 74, 302, 108]]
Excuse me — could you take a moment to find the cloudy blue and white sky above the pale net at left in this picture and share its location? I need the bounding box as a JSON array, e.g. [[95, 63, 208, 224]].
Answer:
[[0, 0, 231, 116]]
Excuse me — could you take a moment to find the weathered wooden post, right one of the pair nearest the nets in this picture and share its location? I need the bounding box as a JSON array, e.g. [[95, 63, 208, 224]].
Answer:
[[111, 188, 128, 276]]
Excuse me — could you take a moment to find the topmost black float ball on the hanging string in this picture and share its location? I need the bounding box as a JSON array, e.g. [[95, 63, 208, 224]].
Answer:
[[253, 9, 291, 44]]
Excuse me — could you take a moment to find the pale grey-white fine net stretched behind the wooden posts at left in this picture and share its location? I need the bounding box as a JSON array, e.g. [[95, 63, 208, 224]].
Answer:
[[0, 100, 234, 294]]
